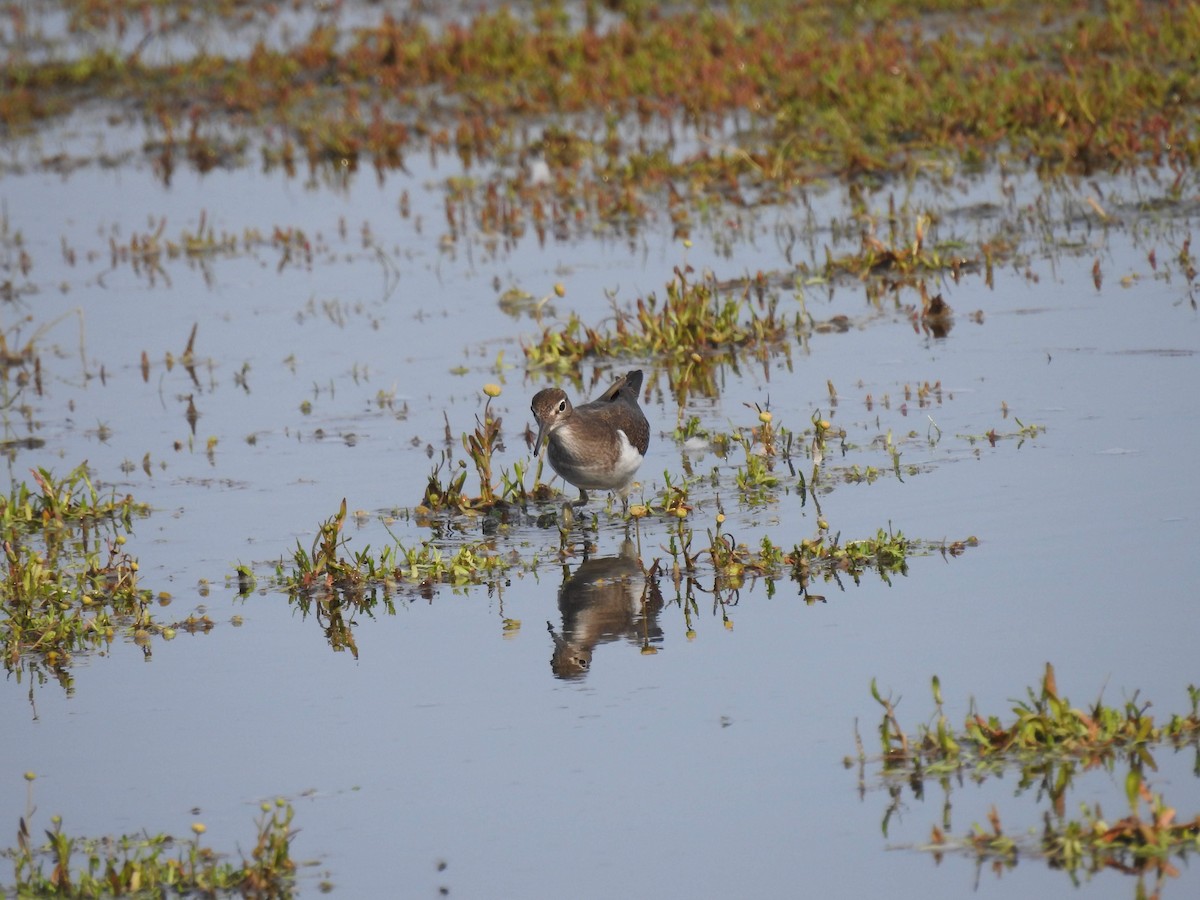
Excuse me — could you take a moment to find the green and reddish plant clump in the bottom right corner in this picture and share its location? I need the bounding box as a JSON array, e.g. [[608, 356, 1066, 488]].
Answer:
[[864, 664, 1200, 880]]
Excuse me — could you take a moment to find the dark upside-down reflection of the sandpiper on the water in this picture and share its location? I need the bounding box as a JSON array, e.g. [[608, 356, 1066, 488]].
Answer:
[[546, 539, 662, 680]]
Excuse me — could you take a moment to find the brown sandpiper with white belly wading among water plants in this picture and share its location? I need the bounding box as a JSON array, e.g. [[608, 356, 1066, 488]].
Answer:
[[533, 368, 650, 509]]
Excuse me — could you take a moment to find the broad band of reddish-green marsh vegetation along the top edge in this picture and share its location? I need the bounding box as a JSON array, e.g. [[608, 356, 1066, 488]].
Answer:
[[0, 0, 1200, 192]]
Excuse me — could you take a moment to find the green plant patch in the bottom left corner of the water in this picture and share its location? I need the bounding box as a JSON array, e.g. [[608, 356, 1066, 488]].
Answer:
[[0, 773, 295, 898]]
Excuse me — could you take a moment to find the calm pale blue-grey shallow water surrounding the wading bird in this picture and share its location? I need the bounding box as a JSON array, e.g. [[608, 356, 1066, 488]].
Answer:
[[0, 21, 1200, 898]]
